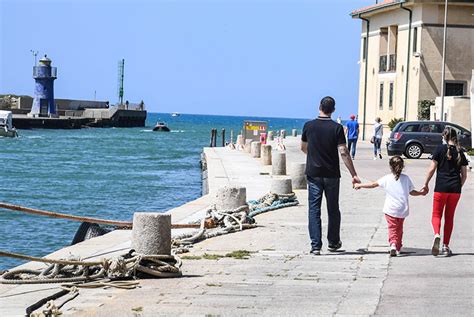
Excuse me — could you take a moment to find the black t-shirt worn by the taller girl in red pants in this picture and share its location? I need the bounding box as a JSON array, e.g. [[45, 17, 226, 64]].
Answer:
[[433, 144, 468, 193]]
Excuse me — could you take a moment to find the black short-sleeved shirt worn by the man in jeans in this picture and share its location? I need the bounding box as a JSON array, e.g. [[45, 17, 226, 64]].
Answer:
[[301, 117, 346, 178]]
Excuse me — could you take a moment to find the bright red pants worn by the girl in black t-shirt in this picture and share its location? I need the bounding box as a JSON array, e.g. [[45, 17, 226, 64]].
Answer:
[[431, 192, 461, 245]]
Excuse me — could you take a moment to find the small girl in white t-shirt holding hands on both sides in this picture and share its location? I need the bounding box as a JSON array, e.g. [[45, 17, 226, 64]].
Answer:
[[354, 156, 425, 256]]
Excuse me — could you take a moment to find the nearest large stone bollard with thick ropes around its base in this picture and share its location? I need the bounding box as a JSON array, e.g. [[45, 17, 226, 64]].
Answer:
[[132, 212, 171, 255]]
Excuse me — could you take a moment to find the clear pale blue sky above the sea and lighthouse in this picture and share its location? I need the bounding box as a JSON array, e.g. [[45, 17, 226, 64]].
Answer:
[[0, 0, 375, 118]]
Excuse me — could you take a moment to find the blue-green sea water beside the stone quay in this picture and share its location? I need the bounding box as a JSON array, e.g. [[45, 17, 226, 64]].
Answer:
[[0, 113, 306, 269]]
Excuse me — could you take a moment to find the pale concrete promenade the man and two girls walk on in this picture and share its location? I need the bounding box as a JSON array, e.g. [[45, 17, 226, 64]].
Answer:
[[0, 137, 474, 316]]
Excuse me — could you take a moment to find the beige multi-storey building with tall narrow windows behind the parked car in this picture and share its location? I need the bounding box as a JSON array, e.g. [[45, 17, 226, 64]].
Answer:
[[352, 0, 474, 138]]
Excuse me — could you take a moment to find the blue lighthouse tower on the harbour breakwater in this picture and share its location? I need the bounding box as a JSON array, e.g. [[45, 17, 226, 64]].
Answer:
[[28, 55, 57, 117]]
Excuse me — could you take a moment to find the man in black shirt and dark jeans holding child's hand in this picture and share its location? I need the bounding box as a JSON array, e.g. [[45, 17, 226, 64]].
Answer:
[[301, 97, 360, 255]]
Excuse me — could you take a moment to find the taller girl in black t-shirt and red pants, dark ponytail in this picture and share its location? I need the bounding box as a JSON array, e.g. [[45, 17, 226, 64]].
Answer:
[[423, 127, 468, 256]]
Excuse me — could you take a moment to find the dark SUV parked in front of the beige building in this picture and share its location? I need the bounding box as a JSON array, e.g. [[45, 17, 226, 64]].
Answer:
[[387, 121, 471, 159]]
